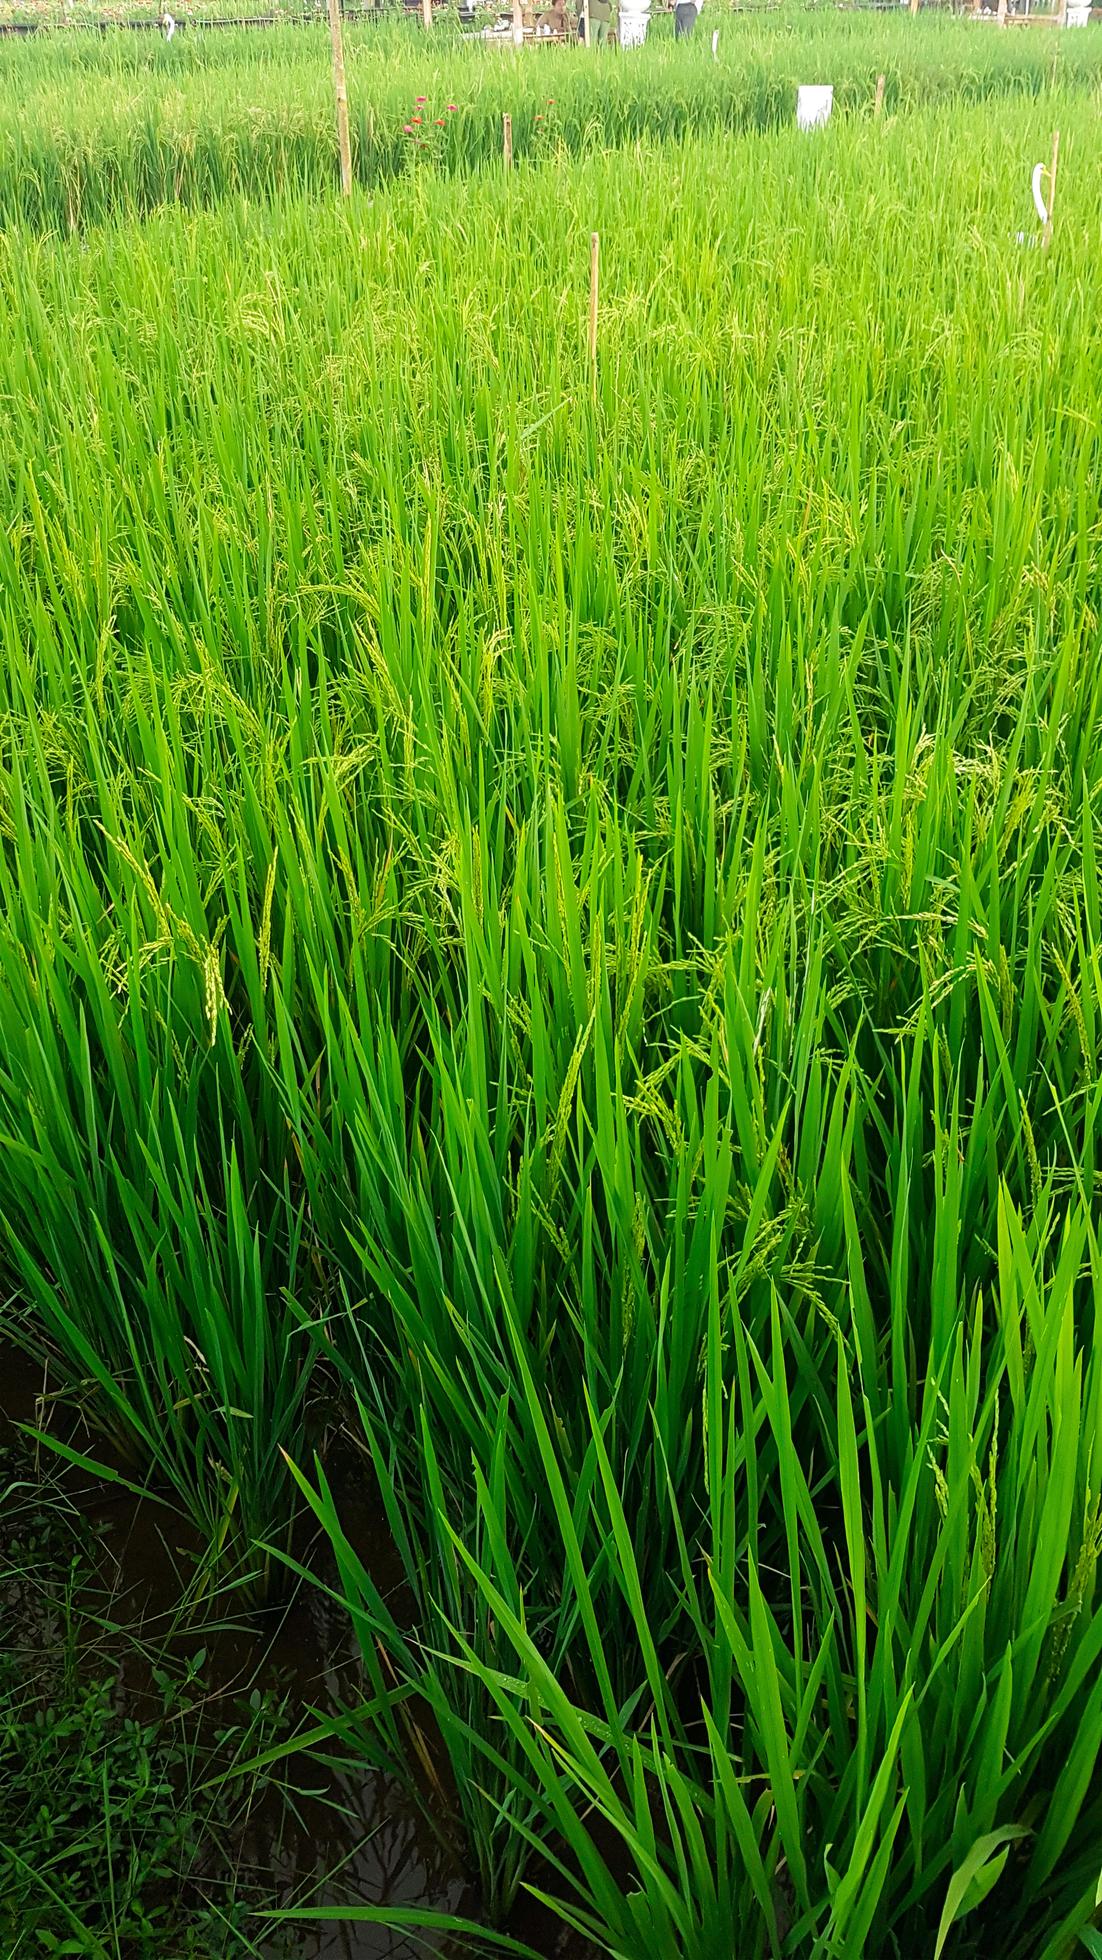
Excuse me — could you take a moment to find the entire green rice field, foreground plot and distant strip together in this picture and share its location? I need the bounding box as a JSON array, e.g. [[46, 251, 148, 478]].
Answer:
[[0, 18, 1102, 1960]]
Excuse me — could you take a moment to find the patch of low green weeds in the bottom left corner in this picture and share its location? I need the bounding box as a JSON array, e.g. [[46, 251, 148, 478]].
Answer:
[[0, 1476, 282, 1960]]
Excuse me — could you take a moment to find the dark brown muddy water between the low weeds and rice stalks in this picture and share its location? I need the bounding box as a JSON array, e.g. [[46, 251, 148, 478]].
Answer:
[[0, 1347, 501, 1960]]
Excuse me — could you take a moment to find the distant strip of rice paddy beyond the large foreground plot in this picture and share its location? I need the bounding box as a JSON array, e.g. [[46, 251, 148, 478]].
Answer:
[[0, 13, 1100, 231]]
